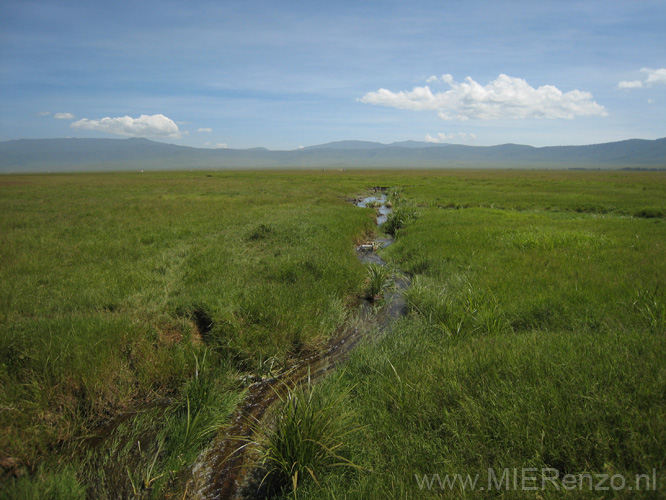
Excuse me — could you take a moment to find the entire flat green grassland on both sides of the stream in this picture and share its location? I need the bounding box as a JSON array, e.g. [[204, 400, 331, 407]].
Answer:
[[0, 170, 666, 498]]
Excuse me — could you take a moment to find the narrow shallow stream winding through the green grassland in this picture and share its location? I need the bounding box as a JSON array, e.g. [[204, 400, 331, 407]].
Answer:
[[185, 188, 409, 500]]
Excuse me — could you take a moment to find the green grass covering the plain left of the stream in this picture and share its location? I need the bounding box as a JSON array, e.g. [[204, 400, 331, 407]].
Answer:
[[0, 172, 372, 498]]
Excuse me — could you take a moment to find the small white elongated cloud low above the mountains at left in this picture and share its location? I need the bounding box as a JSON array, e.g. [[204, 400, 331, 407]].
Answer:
[[70, 114, 182, 138]]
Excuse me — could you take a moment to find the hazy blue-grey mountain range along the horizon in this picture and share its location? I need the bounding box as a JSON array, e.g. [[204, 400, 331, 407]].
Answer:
[[0, 138, 666, 173]]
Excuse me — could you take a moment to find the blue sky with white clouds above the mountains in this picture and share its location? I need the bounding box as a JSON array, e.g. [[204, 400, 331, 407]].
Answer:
[[0, 0, 666, 150]]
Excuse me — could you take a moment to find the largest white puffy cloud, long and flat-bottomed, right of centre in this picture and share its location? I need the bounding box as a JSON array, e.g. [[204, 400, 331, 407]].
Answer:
[[359, 74, 608, 120]]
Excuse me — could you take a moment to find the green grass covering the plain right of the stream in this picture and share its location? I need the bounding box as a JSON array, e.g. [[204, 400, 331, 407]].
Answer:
[[300, 172, 666, 499]]
